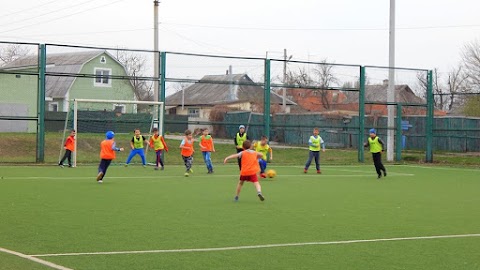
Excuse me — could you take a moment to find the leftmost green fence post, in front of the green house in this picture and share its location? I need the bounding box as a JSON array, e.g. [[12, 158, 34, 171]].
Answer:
[[36, 44, 47, 162]]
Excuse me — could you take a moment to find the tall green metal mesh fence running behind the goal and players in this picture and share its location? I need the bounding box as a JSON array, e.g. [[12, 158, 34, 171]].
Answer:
[[0, 39, 480, 162]]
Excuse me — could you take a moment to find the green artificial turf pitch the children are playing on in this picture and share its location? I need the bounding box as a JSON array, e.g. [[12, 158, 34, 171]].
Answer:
[[0, 163, 480, 270]]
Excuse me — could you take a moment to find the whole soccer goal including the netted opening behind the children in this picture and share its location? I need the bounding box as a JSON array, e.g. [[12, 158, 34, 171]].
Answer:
[[59, 99, 164, 167]]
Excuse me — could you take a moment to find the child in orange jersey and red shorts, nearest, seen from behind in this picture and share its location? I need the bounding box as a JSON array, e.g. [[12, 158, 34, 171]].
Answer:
[[223, 140, 265, 202]]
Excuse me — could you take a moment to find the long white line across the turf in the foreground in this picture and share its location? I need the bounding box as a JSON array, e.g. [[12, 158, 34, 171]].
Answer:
[[29, 234, 480, 257]]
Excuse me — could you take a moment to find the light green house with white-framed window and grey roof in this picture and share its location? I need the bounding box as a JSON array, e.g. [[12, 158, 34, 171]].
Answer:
[[0, 50, 136, 131]]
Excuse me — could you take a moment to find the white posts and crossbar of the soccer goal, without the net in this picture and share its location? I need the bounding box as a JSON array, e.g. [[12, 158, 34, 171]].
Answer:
[[67, 99, 165, 167]]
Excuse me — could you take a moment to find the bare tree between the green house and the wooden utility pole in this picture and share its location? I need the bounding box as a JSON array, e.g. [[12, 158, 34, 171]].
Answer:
[[117, 51, 156, 101]]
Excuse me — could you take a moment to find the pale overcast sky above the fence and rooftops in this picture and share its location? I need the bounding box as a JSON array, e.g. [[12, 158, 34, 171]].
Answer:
[[0, 0, 480, 72]]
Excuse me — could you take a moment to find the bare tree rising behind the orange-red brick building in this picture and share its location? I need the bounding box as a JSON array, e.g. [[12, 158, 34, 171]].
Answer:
[[314, 59, 338, 110]]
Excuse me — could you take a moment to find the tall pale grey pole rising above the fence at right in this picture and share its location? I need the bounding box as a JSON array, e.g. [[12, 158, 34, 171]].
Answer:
[[387, 0, 399, 161]]
